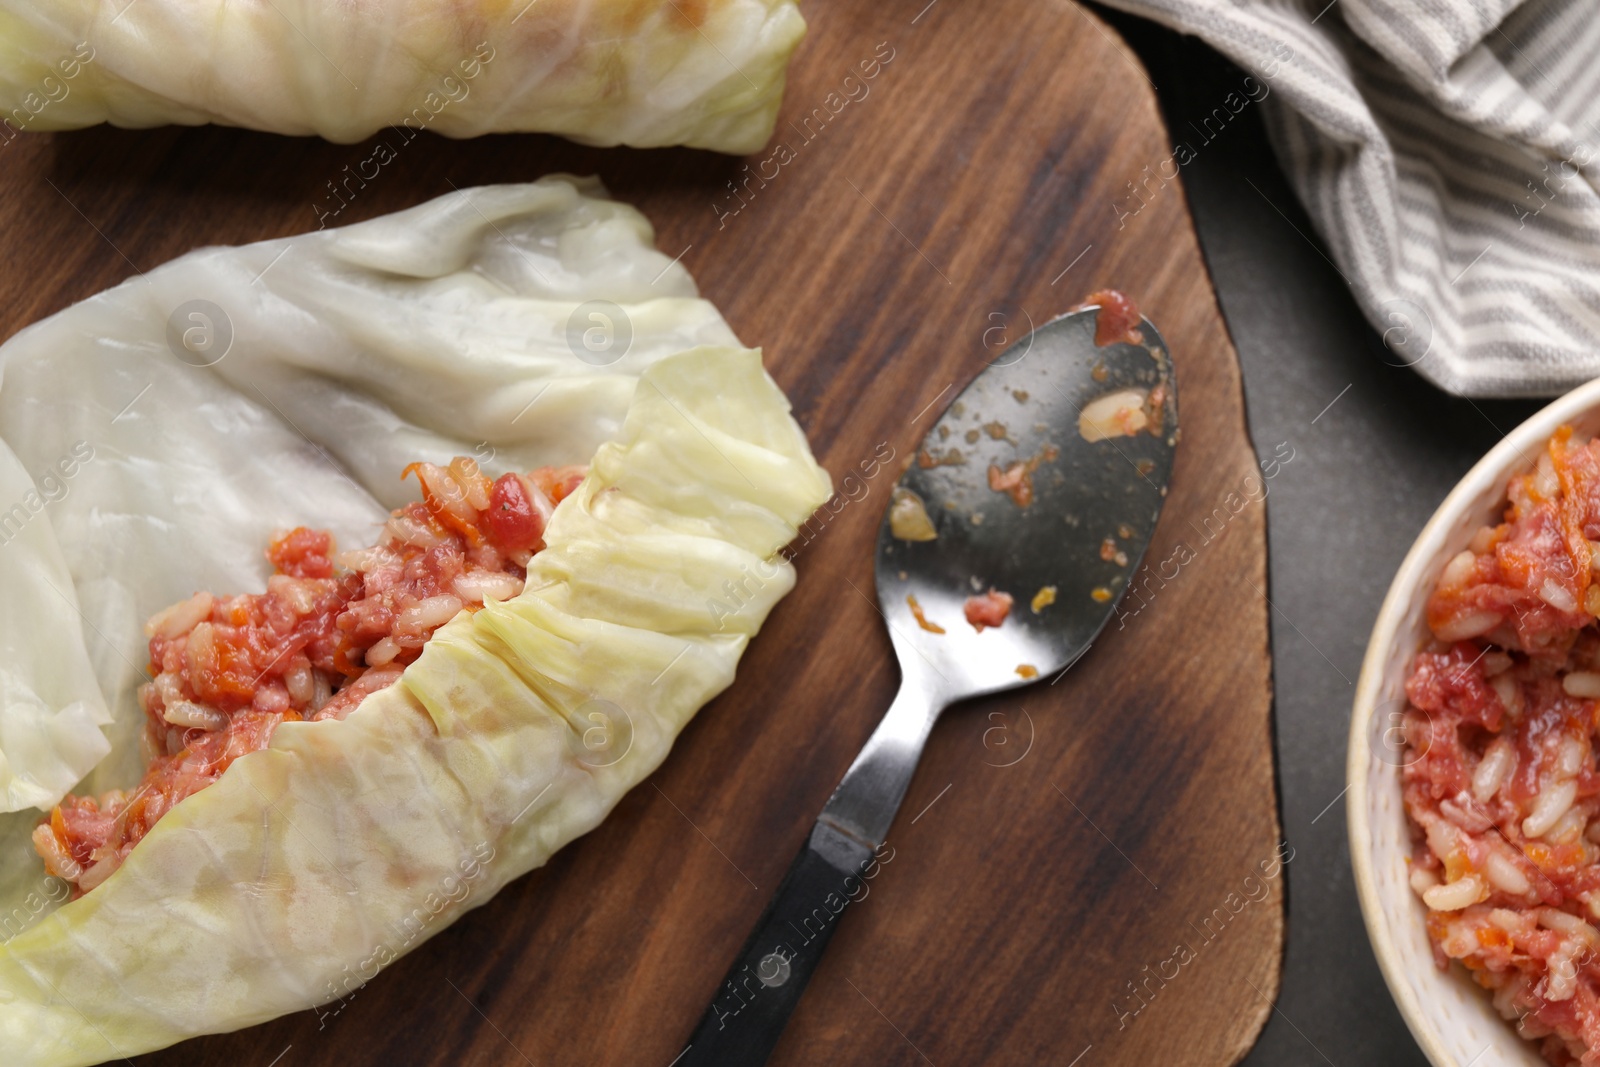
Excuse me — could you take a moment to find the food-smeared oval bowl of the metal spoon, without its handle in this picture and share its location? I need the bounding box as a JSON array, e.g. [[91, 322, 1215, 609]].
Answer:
[[877, 309, 1178, 704]]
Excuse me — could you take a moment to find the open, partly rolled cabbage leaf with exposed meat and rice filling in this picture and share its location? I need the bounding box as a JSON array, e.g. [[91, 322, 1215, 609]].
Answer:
[[0, 178, 830, 1067]]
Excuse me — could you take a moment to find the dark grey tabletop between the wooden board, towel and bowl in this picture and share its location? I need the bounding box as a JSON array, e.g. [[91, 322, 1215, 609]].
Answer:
[[1096, 8, 1541, 1067]]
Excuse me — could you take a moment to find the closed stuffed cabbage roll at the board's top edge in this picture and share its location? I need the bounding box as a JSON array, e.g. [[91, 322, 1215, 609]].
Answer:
[[0, 0, 805, 154]]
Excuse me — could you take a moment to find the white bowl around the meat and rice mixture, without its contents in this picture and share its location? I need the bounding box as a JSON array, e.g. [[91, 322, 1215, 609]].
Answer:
[[1346, 379, 1600, 1067]]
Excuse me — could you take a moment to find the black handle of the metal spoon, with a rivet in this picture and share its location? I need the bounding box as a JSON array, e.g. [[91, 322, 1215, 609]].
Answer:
[[674, 816, 877, 1067]]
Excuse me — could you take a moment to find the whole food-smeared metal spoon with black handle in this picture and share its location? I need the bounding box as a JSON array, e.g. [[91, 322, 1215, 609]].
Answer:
[[674, 306, 1178, 1067]]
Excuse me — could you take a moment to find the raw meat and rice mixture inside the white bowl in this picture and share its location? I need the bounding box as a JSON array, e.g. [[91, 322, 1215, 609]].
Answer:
[[1403, 427, 1600, 1067]]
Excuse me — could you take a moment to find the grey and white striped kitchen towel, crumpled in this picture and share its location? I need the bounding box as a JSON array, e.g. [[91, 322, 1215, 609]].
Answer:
[[1106, 0, 1600, 397]]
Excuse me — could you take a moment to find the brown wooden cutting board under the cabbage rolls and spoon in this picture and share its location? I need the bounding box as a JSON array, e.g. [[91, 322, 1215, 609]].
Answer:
[[0, 0, 1283, 1067]]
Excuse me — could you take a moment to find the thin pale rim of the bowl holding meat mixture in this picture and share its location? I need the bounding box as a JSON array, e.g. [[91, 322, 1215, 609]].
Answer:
[[1344, 379, 1600, 1067]]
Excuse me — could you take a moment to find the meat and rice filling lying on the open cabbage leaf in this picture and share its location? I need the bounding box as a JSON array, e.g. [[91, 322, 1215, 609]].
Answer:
[[34, 458, 584, 896]]
